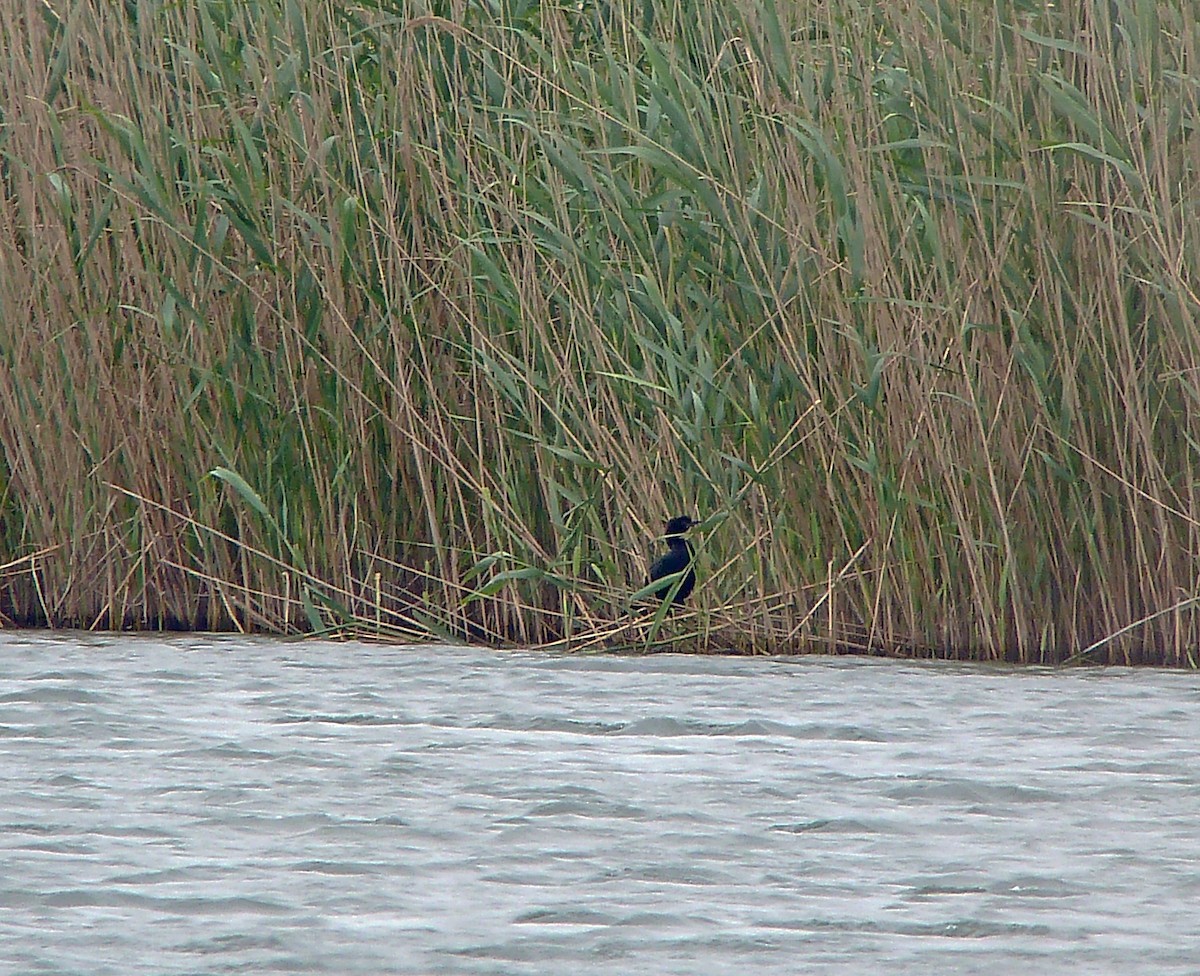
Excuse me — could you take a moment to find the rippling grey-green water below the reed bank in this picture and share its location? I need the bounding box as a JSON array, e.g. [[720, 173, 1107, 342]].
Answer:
[[0, 633, 1200, 976]]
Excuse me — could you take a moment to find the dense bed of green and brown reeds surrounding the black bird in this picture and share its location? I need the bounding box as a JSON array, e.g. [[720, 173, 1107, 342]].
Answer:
[[0, 0, 1200, 666]]
